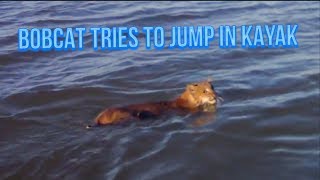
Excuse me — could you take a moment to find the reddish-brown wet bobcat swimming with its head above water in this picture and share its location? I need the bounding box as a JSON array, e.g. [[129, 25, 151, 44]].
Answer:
[[95, 81, 217, 125]]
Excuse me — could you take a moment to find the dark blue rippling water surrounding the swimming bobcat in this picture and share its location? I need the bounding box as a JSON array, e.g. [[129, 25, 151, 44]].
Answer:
[[0, 2, 320, 180]]
